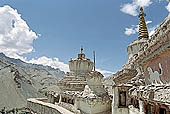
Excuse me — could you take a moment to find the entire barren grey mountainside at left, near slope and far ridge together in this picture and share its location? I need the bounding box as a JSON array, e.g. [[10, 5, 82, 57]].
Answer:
[[0, 53, 64, 109]]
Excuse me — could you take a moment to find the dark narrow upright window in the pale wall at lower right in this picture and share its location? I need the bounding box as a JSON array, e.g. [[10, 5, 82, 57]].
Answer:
[[119, 91, 126, 106]]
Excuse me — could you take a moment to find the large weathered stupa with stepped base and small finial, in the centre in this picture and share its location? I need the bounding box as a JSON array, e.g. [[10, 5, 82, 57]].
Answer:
[[57, 48, 94, 91]]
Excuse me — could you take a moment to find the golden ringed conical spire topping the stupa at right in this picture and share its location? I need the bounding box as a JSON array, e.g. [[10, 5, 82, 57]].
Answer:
[[138, 7, 149, 39]]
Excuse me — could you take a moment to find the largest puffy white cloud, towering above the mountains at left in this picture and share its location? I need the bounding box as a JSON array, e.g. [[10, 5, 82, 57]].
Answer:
[[0, 5, 38, 59]]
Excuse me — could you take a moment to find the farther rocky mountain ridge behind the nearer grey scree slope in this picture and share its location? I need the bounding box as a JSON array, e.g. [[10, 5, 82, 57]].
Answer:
[[0, 53, 64, 90]]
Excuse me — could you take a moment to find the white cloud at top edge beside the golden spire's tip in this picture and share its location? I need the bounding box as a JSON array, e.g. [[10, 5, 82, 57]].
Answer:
[[120, 0, 152, 16]]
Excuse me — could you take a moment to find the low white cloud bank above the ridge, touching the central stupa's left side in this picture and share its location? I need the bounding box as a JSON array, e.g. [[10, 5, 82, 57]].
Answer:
[[27, 56, 69, 72]]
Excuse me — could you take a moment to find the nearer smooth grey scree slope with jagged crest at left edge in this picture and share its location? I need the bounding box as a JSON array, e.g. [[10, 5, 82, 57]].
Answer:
[[0, 61, 42, 109]]
